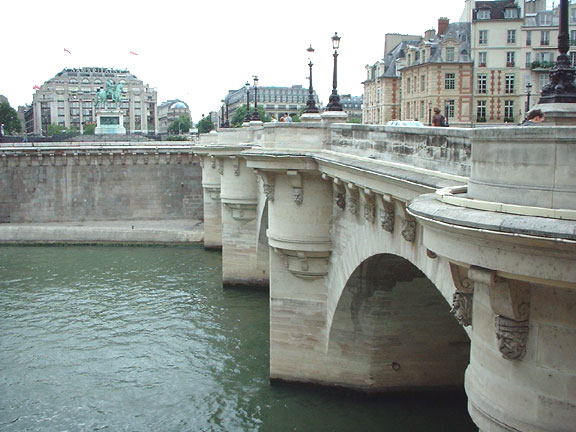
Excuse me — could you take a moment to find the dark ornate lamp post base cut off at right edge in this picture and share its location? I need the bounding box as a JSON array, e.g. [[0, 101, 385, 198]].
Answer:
[[539, 0, 576, 104]]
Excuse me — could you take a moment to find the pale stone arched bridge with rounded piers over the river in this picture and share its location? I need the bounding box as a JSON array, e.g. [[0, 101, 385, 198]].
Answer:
[[194, 122, 576, 431]]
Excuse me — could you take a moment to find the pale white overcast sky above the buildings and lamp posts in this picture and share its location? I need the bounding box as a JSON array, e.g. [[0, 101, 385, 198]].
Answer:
[[0, 0, 528, 122]]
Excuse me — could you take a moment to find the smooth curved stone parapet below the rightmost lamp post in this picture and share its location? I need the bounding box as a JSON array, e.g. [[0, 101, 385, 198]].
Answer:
[[468, 126, 576, 210]]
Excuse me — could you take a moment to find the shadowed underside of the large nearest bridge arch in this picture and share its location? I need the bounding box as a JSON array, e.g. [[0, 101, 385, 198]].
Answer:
[[327, 254, 470, 392]]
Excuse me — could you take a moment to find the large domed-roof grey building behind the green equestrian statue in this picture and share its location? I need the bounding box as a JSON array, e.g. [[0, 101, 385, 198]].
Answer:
[[26, 67, 158, 135]]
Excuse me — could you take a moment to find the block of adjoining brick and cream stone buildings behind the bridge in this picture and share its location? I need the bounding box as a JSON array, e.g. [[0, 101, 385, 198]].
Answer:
[[363, 0, 576, 127]]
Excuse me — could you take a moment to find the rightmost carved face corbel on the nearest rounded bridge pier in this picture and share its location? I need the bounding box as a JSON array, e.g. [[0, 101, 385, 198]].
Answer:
[[468, 267, 530, 360]]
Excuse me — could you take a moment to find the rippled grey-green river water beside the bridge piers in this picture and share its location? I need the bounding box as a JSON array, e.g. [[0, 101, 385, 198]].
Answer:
[[0, 246, 477, 432]]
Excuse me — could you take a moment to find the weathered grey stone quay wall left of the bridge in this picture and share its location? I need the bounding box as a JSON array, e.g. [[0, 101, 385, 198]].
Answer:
[[0, 148, 203, 223]]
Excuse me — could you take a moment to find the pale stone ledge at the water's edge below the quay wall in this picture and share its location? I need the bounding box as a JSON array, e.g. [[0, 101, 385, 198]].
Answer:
[[0, 219, 204, 244]]
